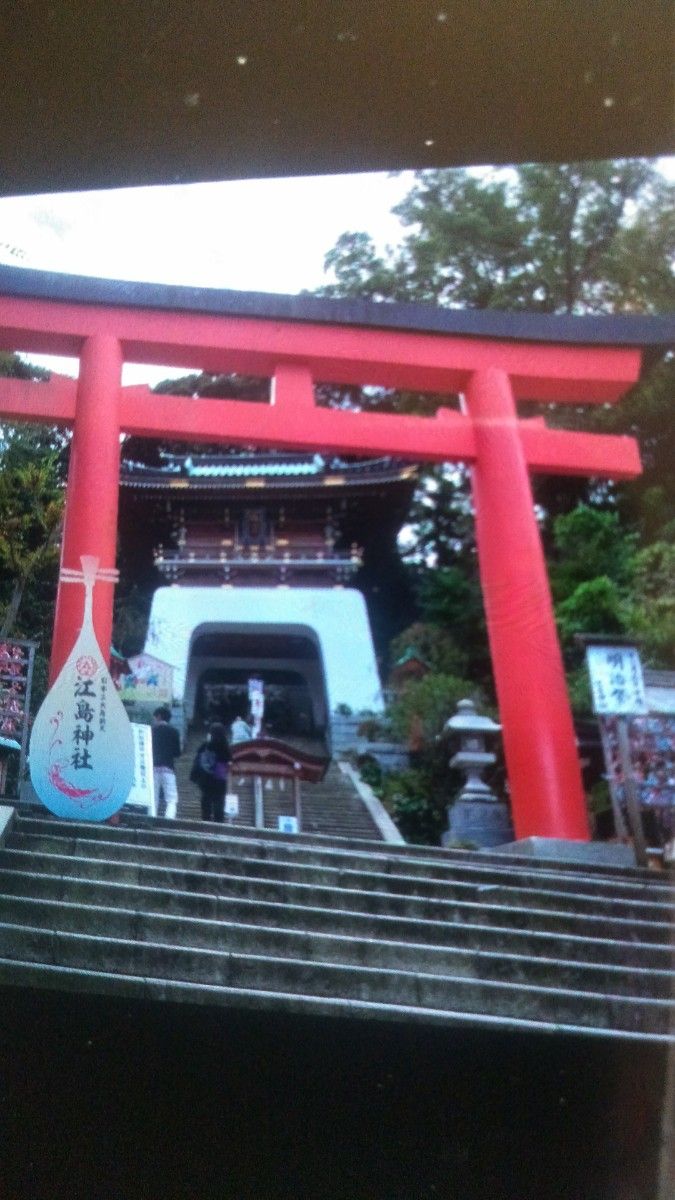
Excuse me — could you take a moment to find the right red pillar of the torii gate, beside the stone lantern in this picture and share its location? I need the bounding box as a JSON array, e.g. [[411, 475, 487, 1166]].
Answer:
[[466, 370, 589, 840]]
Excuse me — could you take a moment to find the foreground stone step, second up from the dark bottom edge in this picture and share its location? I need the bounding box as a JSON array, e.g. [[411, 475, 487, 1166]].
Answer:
[[0, 894, 671, 1000]]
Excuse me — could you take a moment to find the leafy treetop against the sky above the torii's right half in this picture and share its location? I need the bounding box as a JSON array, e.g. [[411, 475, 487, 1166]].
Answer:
[[321, 160, 675, 313]]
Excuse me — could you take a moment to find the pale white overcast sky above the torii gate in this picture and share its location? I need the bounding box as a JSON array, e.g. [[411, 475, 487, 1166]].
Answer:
[[0, 158, 675, 383]]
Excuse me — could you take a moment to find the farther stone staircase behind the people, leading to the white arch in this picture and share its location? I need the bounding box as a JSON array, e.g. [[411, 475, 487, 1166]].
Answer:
[[175, 733, 382, 840]]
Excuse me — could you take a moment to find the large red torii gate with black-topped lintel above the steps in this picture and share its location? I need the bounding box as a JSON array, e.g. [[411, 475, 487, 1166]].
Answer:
[[0, 268, 650, 840]]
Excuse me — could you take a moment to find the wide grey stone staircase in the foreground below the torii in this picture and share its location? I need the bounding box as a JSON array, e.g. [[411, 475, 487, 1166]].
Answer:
[[0, 809, 675, 1042]]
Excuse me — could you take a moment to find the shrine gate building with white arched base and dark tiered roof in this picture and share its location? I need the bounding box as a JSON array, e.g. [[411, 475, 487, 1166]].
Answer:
[[120, 439, 417, 737]]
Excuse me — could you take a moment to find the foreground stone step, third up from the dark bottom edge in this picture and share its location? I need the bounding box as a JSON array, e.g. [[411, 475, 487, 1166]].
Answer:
[[0, 870, 673, 971]]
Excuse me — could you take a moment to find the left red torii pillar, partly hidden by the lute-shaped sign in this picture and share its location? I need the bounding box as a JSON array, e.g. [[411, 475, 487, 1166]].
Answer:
[[49, 334, 123, 683]]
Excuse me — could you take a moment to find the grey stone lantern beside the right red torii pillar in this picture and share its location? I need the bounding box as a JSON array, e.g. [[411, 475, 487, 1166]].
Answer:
[[441, 700, 513, 846]]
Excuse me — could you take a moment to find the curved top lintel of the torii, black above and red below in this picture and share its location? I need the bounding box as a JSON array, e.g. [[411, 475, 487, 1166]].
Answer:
[[0, 266, 674, 404]]
